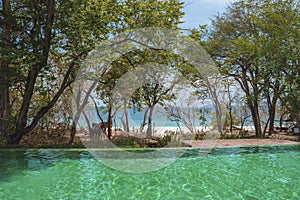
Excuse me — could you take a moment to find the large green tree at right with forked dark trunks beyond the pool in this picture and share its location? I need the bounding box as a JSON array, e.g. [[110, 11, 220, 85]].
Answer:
[[208, 0, 299, 137]]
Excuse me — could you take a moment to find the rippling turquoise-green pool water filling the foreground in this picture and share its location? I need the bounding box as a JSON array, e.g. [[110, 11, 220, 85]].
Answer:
[[0, 145, 300, 200]]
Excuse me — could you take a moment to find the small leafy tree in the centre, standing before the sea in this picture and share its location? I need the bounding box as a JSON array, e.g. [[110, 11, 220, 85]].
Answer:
[[103, 49, 185, 136]]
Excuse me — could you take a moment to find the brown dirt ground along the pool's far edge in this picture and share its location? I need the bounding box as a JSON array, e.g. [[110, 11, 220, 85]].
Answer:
[[20, 130, 299, 147]]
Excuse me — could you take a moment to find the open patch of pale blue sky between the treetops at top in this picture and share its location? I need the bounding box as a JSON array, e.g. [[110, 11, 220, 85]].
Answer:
[[181, 0, 232, 28]]
